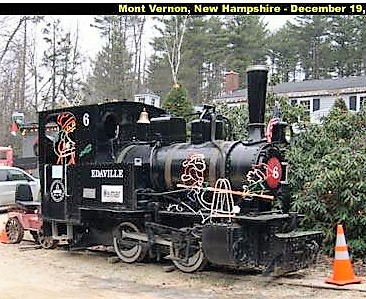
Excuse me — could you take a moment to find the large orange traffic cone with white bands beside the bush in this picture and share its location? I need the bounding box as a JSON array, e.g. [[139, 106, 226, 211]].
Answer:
[[325, 224, 362, 285]]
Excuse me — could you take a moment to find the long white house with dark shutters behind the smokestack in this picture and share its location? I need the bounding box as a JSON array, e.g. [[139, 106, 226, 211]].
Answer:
[[213, 71, 366, 122]]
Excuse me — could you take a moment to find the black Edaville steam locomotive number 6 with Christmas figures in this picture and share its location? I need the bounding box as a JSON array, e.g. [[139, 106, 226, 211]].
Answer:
[[39, 66, 321, 272]]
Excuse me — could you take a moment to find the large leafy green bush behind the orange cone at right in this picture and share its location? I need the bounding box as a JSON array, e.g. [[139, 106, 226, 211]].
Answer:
[[288, 101, 366, 256]]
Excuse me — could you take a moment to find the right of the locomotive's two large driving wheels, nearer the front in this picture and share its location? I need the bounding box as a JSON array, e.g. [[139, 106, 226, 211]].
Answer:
[[171, 231, 207, 273]]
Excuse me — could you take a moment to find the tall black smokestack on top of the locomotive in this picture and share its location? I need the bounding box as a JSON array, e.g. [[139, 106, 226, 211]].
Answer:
[[246, 65, 268, 141]]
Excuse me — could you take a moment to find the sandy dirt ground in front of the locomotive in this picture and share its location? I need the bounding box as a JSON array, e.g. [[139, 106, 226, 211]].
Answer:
[[0, 215, 366, 299]]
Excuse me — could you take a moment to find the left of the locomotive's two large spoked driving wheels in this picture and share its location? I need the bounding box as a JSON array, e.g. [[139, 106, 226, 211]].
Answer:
[[113, 222, 147, 263]]
